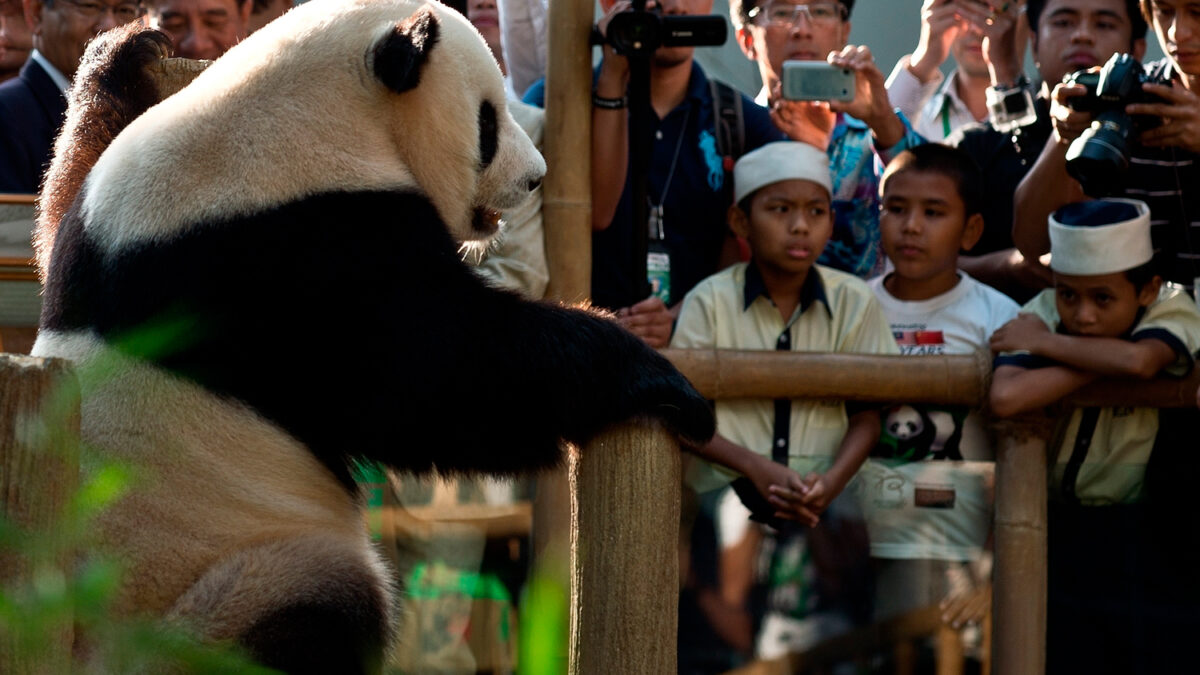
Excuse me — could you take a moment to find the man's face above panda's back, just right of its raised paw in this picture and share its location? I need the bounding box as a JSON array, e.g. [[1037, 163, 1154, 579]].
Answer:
[[146, 0, 254, 59]]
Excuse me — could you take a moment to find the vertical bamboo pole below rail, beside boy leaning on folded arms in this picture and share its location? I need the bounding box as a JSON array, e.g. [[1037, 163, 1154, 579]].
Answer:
[[991, 417, 1050, 675]]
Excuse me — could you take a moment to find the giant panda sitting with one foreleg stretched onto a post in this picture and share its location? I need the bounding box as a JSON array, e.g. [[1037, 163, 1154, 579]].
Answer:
[[34, 0, 714, 673]]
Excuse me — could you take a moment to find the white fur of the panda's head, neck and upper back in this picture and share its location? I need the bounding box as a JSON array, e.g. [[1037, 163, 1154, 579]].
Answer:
[[83, 0, 545, 251]]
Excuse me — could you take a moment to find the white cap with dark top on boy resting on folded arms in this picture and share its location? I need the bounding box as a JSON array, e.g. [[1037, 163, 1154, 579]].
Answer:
[[1050, 199, 1154, 276]]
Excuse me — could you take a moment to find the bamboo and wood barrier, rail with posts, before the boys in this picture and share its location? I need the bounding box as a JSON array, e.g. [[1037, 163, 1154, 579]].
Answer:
[[570, 350, 1200, 675]]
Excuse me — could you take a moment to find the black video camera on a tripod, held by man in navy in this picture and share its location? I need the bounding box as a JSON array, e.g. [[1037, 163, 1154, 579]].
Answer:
[[592, 4, 726, 56]]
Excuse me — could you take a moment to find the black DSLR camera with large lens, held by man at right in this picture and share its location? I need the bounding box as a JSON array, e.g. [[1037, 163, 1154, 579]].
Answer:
[[1063, 54, 1169, 197]]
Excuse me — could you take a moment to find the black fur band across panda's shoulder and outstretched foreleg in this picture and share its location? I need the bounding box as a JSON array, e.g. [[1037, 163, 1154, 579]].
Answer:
[[49, 191, 713, 488]]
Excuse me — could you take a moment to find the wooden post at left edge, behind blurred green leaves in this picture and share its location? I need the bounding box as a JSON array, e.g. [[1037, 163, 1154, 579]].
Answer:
[[0, 354, 79, 675]]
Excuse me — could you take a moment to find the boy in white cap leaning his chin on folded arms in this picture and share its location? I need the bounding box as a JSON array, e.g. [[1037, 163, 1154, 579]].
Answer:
[[990, 199, 1200, 673]]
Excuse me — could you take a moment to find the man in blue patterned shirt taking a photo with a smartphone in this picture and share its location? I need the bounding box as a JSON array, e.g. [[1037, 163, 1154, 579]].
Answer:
[[730, 0, 924, 279]]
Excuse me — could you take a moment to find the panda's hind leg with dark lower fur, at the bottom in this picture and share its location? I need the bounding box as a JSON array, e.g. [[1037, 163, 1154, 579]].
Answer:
[[169, 536, 392, 674]]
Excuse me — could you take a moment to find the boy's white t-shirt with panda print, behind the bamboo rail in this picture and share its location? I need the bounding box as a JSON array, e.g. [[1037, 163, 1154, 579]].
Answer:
[[858, 273, 1020, 561]]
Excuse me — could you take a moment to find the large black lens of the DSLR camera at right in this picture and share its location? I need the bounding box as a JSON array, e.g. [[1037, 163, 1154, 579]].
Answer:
[[1067, 110, 1133, 197]]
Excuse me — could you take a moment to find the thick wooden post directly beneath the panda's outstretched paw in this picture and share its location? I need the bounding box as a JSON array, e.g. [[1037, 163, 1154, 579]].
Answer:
[[569, 423, 682, 675]]
